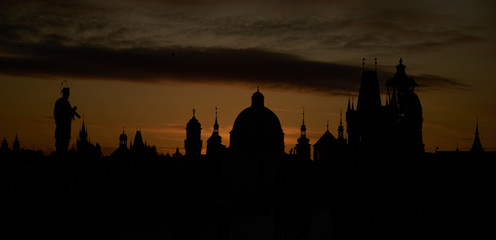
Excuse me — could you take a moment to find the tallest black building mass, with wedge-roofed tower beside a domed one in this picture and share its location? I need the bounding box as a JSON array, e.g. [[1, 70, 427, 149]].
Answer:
[[346, 59, 424, 154]]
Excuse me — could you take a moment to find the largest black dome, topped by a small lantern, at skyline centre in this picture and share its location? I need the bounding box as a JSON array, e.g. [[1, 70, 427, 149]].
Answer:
[[230, 90, 284, 157]]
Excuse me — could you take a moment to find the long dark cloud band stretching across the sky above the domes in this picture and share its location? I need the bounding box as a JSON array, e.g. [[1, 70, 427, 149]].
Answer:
[[0, 41, 466, 94]]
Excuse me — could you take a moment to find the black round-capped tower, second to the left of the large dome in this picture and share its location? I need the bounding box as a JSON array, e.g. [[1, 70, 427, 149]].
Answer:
[[184, 109, 203, 158]]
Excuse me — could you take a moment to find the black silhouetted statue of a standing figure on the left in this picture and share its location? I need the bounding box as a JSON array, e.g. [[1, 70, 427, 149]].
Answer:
[[53, 87, 80, 153]]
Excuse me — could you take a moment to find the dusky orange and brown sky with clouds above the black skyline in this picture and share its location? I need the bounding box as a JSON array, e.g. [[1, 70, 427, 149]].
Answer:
[[0, 0, 496, 154]]
